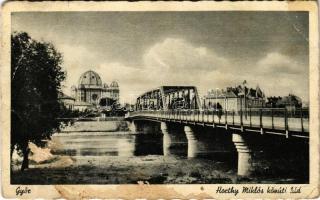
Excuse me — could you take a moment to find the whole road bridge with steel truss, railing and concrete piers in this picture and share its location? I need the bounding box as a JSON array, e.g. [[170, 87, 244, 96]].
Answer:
[[125, 86, 309, 176]]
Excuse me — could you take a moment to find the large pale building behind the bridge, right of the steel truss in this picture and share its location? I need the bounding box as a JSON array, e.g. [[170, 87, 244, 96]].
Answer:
[[202, 85, 266, 111]]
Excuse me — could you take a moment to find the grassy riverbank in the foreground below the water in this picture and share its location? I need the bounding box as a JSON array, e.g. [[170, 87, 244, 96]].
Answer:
[[11, 145, 295, 184]]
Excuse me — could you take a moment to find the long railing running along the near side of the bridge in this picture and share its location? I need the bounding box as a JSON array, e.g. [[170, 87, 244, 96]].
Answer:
[[126, 108, 309, 135]]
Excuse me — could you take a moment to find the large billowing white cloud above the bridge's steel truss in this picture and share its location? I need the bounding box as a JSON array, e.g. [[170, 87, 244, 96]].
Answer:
[[142, 38, 234, 92]]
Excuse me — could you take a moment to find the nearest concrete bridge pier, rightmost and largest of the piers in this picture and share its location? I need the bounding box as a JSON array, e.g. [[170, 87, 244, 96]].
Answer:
[[232, 133, 252, 176]]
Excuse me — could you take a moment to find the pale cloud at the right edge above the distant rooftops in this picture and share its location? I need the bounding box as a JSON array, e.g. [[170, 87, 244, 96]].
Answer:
[[244, 52, 309, 100]]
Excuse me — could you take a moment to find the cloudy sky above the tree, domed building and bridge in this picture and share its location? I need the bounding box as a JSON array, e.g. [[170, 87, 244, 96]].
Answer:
[[12, 11, 309, 103]]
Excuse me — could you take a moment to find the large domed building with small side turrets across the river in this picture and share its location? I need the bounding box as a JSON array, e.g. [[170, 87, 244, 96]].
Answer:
[[71, 70, 120, 109]]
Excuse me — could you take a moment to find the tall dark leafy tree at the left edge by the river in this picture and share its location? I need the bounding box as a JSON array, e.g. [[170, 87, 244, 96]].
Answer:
[[11, 32, 66, 171]]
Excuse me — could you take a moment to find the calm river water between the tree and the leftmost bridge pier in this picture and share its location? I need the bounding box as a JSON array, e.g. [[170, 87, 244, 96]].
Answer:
[[53, 132, 163, 157]]
